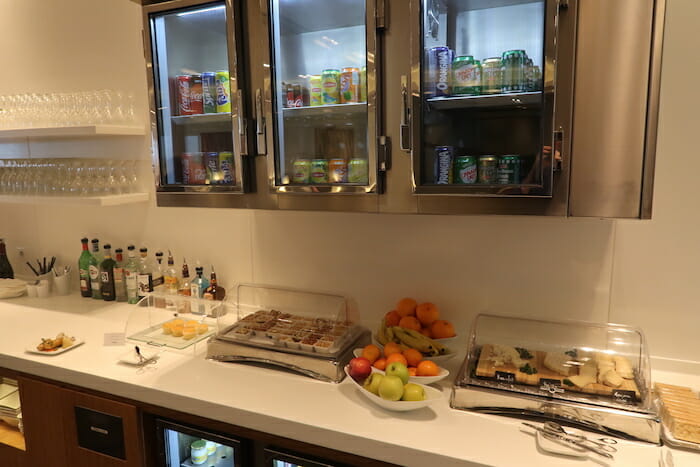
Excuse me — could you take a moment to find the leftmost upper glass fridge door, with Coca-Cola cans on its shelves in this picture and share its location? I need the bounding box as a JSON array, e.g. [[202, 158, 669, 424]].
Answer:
[[144, 0, 247, 192]]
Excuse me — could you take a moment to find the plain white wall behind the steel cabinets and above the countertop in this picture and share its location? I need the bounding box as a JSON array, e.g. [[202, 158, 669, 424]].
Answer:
[[0, 0, 700, 370]]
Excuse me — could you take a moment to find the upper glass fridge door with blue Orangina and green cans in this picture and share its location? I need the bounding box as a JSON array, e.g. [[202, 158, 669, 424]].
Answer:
[[412, 0, 559, 197]]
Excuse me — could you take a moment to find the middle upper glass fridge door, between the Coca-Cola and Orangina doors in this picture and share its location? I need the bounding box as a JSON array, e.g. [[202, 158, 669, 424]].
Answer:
[[269, 0, 377, 193]]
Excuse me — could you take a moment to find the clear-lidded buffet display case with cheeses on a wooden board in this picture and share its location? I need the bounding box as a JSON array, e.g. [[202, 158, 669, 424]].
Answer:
[[450, 315, 660, 443]]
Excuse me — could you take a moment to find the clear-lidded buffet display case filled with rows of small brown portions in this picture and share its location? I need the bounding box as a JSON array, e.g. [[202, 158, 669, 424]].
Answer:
[[207, 284, 370, 382]]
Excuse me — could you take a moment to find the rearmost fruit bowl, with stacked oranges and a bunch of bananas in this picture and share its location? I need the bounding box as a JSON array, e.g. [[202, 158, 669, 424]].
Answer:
[[375, 298, 457, 361]]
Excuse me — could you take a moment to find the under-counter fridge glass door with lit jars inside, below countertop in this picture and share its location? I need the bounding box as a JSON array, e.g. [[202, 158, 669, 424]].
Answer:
[[156, 420, 243, 467]]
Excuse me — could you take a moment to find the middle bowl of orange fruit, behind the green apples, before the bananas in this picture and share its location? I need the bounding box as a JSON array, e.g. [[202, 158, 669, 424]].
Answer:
[[353, 342, 450, 384]]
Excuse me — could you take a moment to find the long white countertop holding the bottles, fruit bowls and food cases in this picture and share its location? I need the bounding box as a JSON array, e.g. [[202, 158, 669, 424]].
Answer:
[[0, 296, 700, 467]]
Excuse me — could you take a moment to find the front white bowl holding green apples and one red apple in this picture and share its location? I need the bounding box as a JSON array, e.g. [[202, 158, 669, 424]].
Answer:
[[345, 357, 442, 412]]
